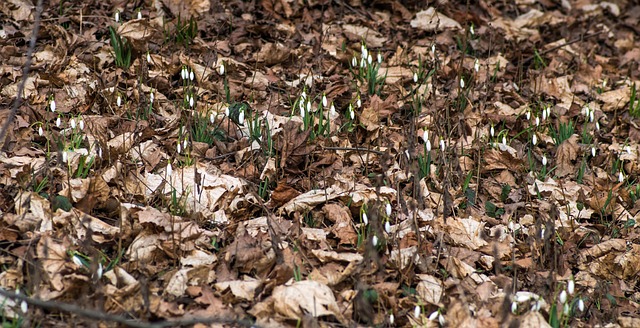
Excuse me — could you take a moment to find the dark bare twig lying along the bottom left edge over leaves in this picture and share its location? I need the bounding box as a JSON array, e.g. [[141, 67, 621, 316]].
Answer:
[[0, 288, 257, 328]]
